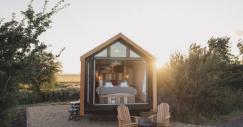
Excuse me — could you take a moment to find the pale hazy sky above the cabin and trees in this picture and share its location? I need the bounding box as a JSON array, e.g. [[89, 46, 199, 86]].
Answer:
[[0, 0, 243, 74]]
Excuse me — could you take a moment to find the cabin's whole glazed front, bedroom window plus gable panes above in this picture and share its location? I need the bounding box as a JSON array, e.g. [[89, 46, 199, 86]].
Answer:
[[93, 41, 147, 105]]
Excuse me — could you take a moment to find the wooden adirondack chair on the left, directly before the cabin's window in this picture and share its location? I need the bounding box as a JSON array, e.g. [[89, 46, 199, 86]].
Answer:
[[117, 104, 140, 127]]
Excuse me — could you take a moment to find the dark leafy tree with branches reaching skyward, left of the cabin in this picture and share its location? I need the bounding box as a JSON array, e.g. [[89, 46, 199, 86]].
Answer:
[[0, 0, 68, 109]]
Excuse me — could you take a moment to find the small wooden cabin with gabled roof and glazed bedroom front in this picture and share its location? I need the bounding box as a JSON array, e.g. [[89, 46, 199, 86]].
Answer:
[[80, 33, 157, 116]]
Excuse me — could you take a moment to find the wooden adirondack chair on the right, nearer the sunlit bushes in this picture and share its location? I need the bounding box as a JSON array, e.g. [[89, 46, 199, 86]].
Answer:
[[149, 103, 170, 127]]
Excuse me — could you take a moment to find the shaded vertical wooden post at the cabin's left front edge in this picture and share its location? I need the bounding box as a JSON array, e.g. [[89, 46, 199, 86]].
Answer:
[[79, 59, 85, 116]]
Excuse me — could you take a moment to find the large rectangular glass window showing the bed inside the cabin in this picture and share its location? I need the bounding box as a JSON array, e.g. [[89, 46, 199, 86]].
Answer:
[[93, 59, 148, 105]]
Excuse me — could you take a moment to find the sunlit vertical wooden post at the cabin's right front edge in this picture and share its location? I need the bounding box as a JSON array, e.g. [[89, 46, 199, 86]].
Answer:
[[152, 65, 158, 112]]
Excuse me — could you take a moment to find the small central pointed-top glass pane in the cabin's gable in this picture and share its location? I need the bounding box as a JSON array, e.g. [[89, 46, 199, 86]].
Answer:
[[110, 42, 127, 57]]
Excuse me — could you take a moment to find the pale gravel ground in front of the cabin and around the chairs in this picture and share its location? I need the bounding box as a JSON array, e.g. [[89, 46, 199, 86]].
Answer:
[[26, 105, 215, 127]]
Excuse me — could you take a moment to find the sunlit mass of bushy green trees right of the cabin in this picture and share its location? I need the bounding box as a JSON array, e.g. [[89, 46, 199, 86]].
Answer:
[[158, 37, 243, 123]]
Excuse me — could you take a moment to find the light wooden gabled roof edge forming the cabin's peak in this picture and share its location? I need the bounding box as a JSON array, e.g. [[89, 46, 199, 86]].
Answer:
[[81, 33, 155, 60]]
